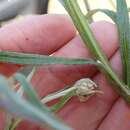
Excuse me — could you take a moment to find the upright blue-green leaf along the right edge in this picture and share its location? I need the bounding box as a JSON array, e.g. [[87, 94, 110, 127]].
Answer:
[[116, 0, 130, 87]]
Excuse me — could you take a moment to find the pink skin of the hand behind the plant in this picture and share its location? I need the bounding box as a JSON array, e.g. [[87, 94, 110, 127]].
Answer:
[[0, 15, 130, 130]]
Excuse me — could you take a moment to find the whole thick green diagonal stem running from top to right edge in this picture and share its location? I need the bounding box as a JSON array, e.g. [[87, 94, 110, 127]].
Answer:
[[62, 0, 130, 103]]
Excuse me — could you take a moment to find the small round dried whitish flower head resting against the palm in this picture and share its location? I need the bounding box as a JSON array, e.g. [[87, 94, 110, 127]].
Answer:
[[73, 78, 103, 102]]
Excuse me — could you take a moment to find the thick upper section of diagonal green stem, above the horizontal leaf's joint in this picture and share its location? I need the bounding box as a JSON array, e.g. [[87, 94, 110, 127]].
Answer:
[[59, 0, 107, 62]]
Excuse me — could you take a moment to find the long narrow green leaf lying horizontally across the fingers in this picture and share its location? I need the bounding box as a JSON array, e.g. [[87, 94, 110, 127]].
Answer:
[[0, 51, 99, 65]]
